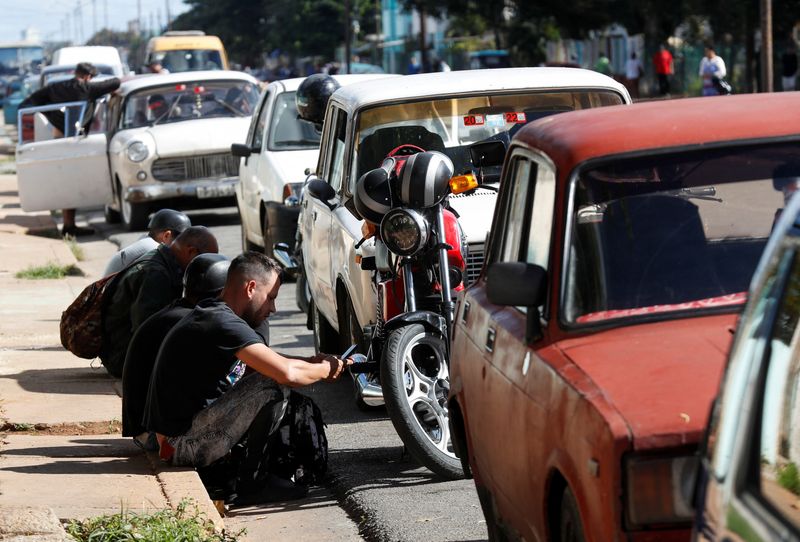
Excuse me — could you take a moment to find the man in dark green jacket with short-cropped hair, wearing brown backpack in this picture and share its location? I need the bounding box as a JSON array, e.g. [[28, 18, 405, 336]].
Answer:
[[100, 226, 219, 378]]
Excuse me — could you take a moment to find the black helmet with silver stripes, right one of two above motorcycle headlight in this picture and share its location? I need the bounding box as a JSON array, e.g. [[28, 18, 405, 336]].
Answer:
[[395, 151, 454, 208]]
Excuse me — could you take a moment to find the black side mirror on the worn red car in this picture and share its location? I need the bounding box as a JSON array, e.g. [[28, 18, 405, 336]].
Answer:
[[486, 262, 547, 344]]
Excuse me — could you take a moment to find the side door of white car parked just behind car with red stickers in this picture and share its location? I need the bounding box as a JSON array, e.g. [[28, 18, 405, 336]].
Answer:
[[236, 90, 275, 245]]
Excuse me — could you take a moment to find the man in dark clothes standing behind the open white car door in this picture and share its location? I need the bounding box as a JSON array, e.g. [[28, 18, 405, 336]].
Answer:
[[19, 62, 120, 236]]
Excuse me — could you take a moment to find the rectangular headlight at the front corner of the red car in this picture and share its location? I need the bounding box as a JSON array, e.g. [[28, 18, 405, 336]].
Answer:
[[625, 455, 699, 528]]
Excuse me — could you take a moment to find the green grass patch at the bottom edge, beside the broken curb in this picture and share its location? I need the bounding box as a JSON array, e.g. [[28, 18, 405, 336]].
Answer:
[[66, 499, 245, 542]]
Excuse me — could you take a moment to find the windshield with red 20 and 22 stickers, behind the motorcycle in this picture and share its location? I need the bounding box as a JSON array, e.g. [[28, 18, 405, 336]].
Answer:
[[350, 90, 622, 192]]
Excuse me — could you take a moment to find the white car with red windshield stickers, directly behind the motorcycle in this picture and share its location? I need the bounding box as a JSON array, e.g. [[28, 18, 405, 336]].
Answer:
[[297, 68, 631, 353]]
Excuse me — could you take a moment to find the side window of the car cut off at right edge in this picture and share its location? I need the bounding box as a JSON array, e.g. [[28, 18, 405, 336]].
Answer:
[[758, 256, 800, 529]]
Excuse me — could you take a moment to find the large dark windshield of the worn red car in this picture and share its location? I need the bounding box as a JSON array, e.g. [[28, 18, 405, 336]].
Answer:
[[564, 143, 800, 324]]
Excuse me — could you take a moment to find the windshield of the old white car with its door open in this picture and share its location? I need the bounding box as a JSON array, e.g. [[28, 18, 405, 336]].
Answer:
[[120, 81, 258, 129]]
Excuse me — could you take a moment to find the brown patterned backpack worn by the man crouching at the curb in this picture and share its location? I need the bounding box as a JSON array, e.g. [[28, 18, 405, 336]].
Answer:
[[60, 268, 122, 359]]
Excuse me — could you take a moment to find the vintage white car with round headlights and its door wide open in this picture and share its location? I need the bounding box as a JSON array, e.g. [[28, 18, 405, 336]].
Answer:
[[17, 71, 259, 230]]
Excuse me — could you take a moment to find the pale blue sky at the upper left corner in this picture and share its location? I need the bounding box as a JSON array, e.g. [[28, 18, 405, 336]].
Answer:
[[0, 0, 189, 44]]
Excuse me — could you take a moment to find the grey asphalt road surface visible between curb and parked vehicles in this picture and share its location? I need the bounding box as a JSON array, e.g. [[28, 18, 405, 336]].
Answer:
[[88, 207, 487, 541]]
